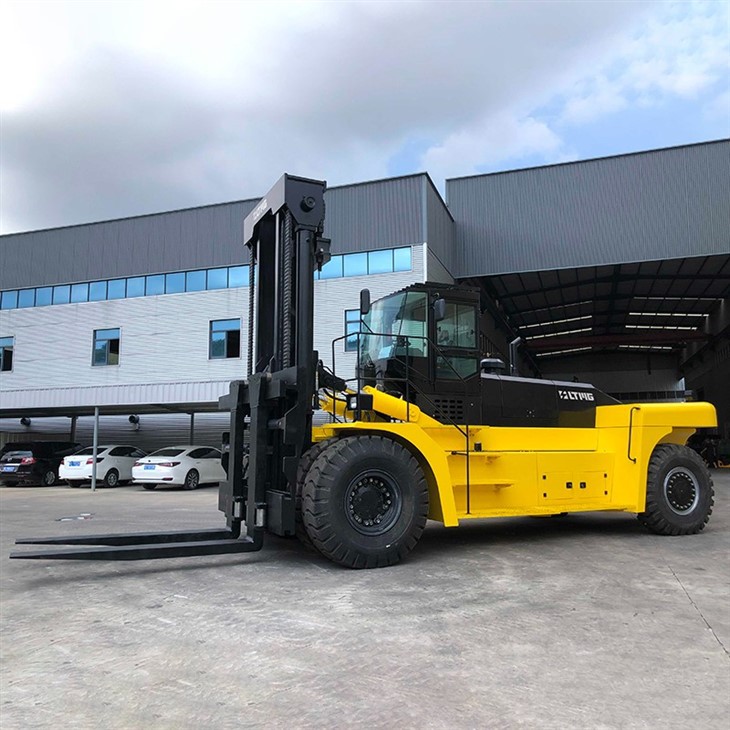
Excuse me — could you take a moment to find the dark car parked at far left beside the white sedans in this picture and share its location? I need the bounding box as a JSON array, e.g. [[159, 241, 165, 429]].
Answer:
[[0, 441, 81, 487]]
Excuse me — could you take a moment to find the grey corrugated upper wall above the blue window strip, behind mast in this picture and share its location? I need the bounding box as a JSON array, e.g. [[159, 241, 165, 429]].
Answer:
[[0, 174, 432, 289]]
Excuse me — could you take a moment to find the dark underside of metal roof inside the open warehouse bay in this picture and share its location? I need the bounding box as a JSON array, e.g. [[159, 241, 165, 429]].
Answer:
[[464, 253, 730, 359]]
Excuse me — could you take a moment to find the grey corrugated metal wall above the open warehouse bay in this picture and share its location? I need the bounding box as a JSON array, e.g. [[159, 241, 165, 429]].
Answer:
[[446, 140, 730, 276]]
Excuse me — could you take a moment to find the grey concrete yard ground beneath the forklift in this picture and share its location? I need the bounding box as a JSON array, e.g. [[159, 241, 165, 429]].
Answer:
[[0, 471, 730, 730]]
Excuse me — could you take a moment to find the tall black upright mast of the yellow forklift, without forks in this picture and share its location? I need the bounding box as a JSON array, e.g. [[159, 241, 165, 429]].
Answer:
[[218, 175, 330, 535]]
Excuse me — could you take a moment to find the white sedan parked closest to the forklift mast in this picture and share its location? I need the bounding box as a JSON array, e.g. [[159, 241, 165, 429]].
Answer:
[[132, 446, 226, 489]]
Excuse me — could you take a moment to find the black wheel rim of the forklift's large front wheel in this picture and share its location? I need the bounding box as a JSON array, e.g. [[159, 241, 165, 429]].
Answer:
[[345, 469, 403, 535]]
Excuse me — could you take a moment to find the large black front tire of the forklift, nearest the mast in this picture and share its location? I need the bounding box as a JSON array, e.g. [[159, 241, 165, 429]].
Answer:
[[302, 436, 428, 568]]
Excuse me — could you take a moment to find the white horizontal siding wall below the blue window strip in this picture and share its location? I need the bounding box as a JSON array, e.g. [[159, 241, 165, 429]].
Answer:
[[0, 245, 425, 407]]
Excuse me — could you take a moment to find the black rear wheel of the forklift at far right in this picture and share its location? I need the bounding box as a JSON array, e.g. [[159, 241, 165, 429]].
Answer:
[[638, 444, 715, 535]]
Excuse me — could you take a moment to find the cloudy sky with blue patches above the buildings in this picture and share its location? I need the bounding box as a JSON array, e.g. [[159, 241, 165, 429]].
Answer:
[[0, 0, 730, 233]]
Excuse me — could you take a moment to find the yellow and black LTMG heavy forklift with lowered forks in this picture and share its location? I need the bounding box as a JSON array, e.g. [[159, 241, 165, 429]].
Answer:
[[11, 175, 716, 568]]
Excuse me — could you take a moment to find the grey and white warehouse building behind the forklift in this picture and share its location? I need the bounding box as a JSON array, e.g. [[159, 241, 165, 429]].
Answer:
[[0, 140, 730, 449]]
